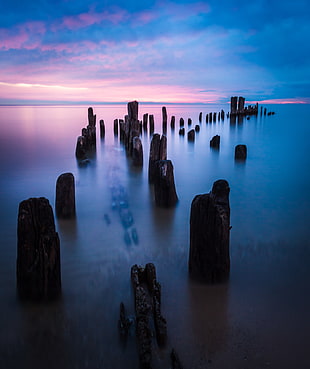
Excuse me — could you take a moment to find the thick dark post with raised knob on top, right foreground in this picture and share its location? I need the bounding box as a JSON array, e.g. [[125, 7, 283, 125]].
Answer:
[[188, 180, 230, 283]]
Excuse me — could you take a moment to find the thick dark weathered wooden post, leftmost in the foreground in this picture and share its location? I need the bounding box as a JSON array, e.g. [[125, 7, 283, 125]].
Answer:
[[16, 197, 61, 300]]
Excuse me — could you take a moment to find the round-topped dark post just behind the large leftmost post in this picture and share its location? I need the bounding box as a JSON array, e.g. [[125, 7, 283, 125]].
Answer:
[[55, 173, 75, 219]]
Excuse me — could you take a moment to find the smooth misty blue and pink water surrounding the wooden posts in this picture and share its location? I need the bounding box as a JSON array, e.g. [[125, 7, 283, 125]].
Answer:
[[0, 104, 310, 369]]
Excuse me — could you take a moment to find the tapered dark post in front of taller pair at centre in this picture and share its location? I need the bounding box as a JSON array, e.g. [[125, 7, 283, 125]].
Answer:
[[154, 160, 178, 207]]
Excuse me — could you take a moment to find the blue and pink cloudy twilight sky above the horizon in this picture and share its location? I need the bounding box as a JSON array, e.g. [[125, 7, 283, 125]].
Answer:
[[0, 0, 310, 104]]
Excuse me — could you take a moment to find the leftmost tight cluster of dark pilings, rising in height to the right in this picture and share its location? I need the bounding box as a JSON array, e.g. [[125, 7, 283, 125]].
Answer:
[[75, 108, 96, 161]]
